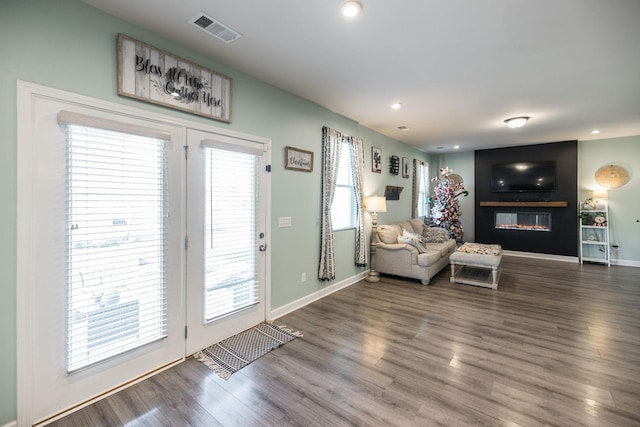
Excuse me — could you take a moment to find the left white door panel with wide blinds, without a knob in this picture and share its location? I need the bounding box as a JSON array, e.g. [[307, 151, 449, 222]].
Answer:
[[18, 91, 185, 423]]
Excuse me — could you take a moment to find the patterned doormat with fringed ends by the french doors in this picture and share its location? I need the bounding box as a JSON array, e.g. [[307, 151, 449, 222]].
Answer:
[[193, 323, 302, 380]]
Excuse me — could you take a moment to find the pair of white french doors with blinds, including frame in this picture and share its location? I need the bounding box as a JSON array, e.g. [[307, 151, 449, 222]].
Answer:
[[17, 83, 269, 425]]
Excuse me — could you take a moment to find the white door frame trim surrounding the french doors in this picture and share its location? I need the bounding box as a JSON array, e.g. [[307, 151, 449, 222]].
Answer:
[[16, 80, 271, 425]]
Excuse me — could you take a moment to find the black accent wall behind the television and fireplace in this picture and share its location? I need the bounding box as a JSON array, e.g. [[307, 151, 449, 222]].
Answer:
[[475, 141, 578, 256]]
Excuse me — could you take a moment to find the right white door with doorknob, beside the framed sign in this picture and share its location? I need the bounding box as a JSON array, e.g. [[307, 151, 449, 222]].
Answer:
[[186, 130, 268, 355]]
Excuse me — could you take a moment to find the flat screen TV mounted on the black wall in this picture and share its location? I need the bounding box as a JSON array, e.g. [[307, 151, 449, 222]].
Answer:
[[491, 161, 556, 193]]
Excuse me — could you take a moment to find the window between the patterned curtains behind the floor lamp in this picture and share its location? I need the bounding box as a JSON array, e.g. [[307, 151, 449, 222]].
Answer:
[[331, 141, 356, 230]]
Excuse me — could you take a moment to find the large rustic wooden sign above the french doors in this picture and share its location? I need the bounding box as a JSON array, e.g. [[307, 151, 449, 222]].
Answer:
[[118, 34, 232, 123]]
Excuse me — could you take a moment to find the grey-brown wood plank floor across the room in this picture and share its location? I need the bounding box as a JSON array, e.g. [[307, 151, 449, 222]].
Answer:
[[52, 257, 640, 427]]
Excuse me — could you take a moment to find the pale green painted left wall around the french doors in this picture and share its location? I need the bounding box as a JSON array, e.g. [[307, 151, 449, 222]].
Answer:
[[0, 0, 428, 425]]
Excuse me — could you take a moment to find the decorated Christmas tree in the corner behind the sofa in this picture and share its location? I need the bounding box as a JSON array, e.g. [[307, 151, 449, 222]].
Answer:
[[429, 167, 469, 243]]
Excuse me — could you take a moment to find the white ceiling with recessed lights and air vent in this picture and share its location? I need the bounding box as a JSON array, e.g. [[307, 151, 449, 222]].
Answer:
[[83, 0, 640, 152]]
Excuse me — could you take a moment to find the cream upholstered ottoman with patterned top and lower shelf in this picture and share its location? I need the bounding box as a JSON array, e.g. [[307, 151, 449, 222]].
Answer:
[[449, 243, 502, 289]]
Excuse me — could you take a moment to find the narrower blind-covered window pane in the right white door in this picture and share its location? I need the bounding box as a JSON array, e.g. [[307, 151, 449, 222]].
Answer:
[[203, 144, 261, 322]]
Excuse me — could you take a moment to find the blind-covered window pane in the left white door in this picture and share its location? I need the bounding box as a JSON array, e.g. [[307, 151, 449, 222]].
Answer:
[[63, 123, 168, 372]]
